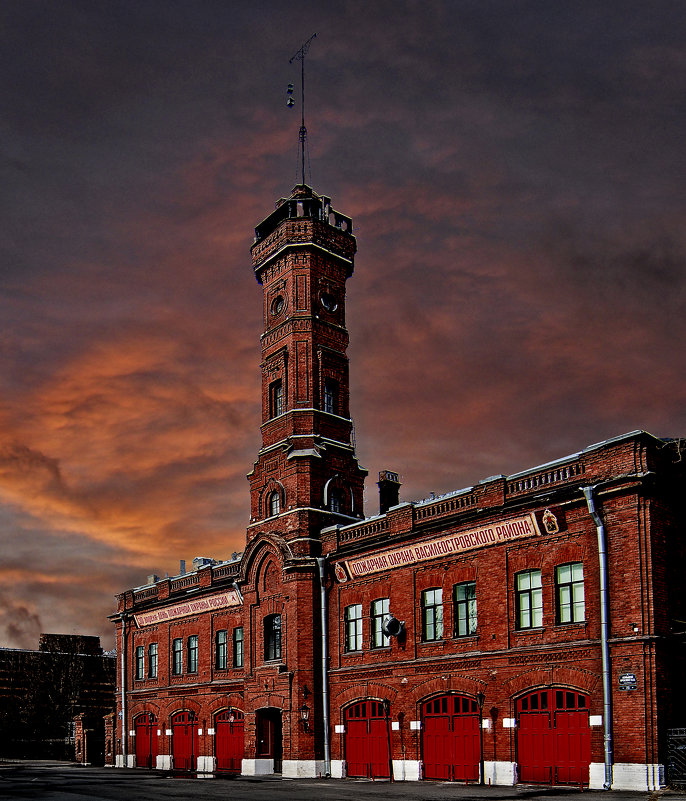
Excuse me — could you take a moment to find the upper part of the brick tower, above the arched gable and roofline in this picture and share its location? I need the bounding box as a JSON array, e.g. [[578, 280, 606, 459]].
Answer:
[[248, 185, 366, 555]]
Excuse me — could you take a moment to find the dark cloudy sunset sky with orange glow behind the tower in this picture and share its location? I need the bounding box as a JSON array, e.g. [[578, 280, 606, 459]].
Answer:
[[0, 0, 686, 648]]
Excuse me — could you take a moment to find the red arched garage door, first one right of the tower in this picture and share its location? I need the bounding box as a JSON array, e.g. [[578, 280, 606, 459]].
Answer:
[[345, 701, 389, 779]]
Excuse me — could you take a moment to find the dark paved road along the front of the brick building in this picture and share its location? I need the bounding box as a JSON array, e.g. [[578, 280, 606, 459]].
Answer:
[[0, 761, 686, 801]]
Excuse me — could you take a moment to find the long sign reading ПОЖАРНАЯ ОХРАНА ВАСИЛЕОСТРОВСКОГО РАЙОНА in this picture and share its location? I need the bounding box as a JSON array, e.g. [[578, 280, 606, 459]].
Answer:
[[334, 515, 540, 581]]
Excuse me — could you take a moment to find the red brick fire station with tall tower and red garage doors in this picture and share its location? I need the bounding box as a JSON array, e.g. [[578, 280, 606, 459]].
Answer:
[[111, 185, 686, 790]]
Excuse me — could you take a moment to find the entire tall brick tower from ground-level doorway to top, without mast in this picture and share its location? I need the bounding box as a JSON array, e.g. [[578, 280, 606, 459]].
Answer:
[[239, 184, 366, 776]]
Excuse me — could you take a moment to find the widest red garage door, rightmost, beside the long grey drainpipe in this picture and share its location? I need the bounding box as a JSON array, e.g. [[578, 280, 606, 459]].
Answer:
[[517, 689, 591, 784]]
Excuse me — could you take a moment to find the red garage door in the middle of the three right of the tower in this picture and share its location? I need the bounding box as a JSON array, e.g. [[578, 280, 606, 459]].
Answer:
[[422, 695, 481, 781]]
